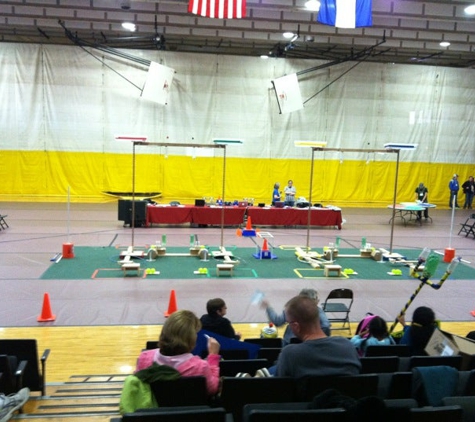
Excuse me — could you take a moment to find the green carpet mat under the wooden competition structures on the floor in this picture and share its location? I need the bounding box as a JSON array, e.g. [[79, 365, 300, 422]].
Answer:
[[41, 246, 475, 282]]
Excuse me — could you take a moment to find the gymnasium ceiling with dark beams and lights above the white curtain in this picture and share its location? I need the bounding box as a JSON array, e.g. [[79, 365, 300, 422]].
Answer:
[[0, 0, 475, 68]]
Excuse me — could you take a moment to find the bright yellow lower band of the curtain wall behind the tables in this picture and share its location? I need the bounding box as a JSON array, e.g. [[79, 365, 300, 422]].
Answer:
[[0, 150, 470, 207]]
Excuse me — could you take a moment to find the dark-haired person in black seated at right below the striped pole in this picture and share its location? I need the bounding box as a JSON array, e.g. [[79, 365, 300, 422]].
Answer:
[[399, 306, 437, 356]]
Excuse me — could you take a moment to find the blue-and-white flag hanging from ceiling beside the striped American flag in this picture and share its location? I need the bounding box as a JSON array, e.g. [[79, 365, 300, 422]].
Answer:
[[317, 0, 373, 28]]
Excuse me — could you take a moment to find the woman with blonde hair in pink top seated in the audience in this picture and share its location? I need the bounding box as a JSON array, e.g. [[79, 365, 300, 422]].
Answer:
[[135, 310, 221, 395]]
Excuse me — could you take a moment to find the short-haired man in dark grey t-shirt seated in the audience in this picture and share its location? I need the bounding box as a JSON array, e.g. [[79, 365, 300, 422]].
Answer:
[[276, 295, 361, 378]]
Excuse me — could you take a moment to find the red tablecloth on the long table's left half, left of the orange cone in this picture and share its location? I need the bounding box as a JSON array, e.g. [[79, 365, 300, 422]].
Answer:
[[147, 205, 246, 226]]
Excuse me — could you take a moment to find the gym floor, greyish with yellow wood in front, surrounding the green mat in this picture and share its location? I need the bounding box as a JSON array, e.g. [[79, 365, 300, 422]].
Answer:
[[0, 202, 475, 422]]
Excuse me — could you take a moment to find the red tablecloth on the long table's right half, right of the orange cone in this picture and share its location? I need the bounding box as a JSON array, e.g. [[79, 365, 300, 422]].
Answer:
[[247, 207, 342, 229]]
